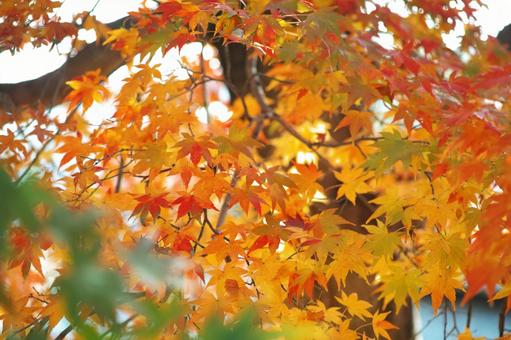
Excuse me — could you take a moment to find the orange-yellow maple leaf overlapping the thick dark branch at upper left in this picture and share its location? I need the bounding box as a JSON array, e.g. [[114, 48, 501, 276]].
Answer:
[[65, 69, 110, 112]]
